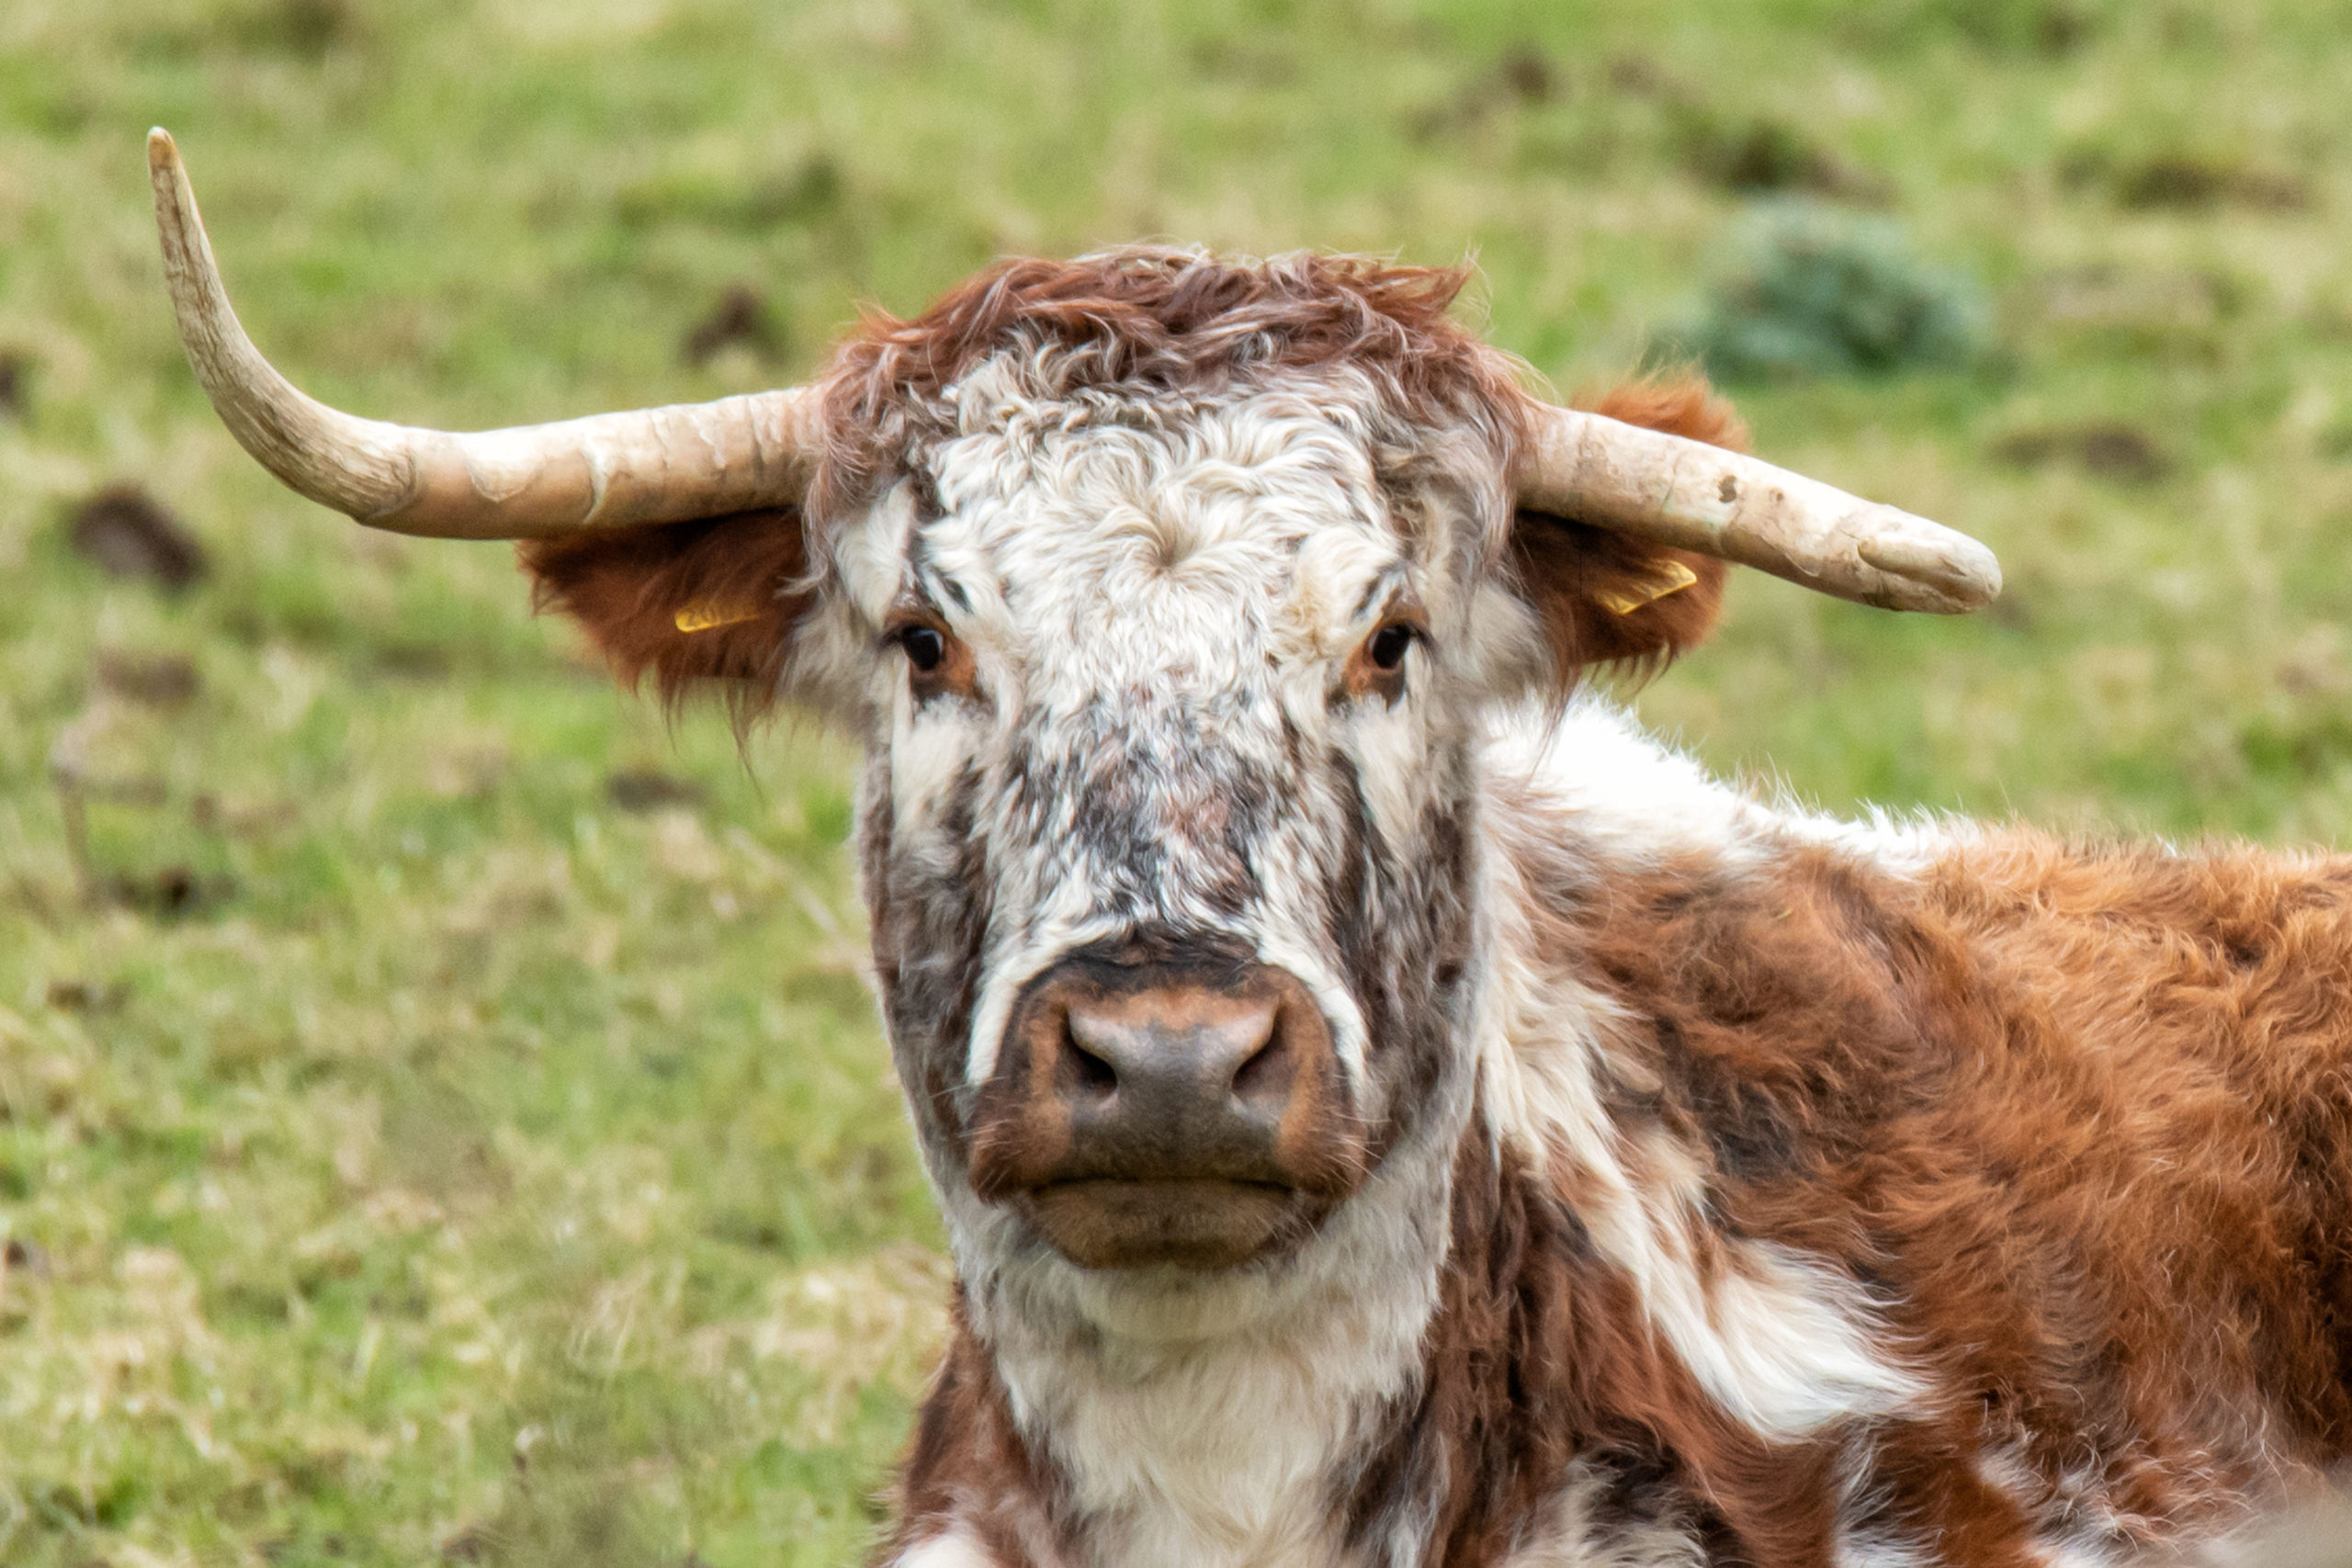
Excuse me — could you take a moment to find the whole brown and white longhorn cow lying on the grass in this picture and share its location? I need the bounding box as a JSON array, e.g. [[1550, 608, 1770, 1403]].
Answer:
[[151, 131, 2352, 1568]]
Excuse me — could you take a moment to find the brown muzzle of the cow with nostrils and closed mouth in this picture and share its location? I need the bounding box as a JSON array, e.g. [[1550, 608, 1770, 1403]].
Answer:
[[971, 959, 1366, 1267]]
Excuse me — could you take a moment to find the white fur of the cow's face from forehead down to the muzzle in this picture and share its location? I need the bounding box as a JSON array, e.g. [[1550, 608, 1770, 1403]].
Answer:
[[835, 353, 1541, 1100]]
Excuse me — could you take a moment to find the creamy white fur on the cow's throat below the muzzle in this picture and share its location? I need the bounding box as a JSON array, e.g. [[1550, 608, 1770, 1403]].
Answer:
[[932, 1081, 1473, 1568]]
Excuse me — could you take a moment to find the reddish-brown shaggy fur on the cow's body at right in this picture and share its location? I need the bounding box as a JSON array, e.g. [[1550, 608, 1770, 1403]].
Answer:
[[1467, 808, 2352, 1568]]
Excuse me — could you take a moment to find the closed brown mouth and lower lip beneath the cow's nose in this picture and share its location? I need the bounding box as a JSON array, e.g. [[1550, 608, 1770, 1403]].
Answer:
[[1018, 1178, 1329, 1272]]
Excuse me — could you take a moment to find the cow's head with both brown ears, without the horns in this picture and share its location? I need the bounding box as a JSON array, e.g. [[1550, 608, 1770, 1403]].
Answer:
[[526, 254, 1722, 1325]]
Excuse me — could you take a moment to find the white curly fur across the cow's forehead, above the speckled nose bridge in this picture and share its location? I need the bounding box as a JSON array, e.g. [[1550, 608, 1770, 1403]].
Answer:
[[835, 353, 1524, 677]]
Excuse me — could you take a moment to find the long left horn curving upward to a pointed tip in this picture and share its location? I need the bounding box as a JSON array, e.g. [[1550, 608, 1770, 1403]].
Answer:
[[148, 127, 819, 538]]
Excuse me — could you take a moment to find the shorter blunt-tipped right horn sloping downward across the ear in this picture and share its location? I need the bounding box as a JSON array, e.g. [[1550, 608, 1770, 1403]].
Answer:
[[1517, 404, 2002, 616]]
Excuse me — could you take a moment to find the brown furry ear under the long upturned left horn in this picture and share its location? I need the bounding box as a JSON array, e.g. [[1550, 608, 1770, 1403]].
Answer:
[[517, 508, 814, 724]]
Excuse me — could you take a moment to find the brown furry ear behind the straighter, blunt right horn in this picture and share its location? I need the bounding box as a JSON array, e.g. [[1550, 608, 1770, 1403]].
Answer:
[[1510, 378, 1747, 682]]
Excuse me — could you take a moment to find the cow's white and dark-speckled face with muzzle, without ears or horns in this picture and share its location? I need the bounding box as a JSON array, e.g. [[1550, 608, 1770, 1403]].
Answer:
[[837, 362, 1505, 1269]]
